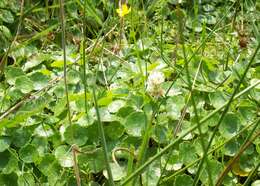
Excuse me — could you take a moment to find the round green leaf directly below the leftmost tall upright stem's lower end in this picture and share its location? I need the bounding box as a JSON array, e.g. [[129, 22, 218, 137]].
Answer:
[[64, 124, 88, 146]]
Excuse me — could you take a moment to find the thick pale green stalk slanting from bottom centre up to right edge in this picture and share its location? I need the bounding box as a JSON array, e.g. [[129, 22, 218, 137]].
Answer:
[[121, 81, 260, 185]]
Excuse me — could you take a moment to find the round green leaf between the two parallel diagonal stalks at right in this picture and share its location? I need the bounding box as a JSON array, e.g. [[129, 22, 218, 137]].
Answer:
[[219, 113, 241, 138]]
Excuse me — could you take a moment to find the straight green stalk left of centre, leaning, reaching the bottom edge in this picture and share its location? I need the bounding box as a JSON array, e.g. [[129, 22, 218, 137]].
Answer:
[[92, 87, 115, 186]]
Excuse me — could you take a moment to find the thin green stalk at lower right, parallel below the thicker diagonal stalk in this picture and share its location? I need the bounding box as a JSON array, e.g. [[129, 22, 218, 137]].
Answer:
[[162, 117, 257, 183]]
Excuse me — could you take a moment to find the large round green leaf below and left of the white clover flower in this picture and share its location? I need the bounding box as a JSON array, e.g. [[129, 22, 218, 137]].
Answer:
[[125, 112, 146, 137]]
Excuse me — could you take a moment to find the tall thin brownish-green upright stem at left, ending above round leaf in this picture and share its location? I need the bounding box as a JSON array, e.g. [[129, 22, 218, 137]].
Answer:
[[60, 0, 72, 125]]
